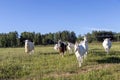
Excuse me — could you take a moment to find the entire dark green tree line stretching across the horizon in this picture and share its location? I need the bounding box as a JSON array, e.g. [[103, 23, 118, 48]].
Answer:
[[0, 30, 120, 47]]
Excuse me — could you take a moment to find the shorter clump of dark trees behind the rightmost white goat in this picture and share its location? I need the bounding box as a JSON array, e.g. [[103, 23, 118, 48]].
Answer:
[[86, 31, 120, 42]]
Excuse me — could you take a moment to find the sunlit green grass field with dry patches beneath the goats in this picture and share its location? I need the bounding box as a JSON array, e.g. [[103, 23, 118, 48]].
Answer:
[[0, 42, 120, 80]]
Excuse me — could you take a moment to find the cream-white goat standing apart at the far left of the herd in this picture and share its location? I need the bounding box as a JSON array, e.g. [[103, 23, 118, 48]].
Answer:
[[25, 40, 34, 54]]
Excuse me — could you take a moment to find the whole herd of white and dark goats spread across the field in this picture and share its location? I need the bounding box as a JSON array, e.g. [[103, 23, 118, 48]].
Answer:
[[25, 36, 112, 67]]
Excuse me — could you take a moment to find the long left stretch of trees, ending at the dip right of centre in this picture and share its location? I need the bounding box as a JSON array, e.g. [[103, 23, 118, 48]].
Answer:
[[0, 31, 77, 47]]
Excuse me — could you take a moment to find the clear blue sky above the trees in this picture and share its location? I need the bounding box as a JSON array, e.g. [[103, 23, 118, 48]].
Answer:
[[0, 0, 120, 35]]
